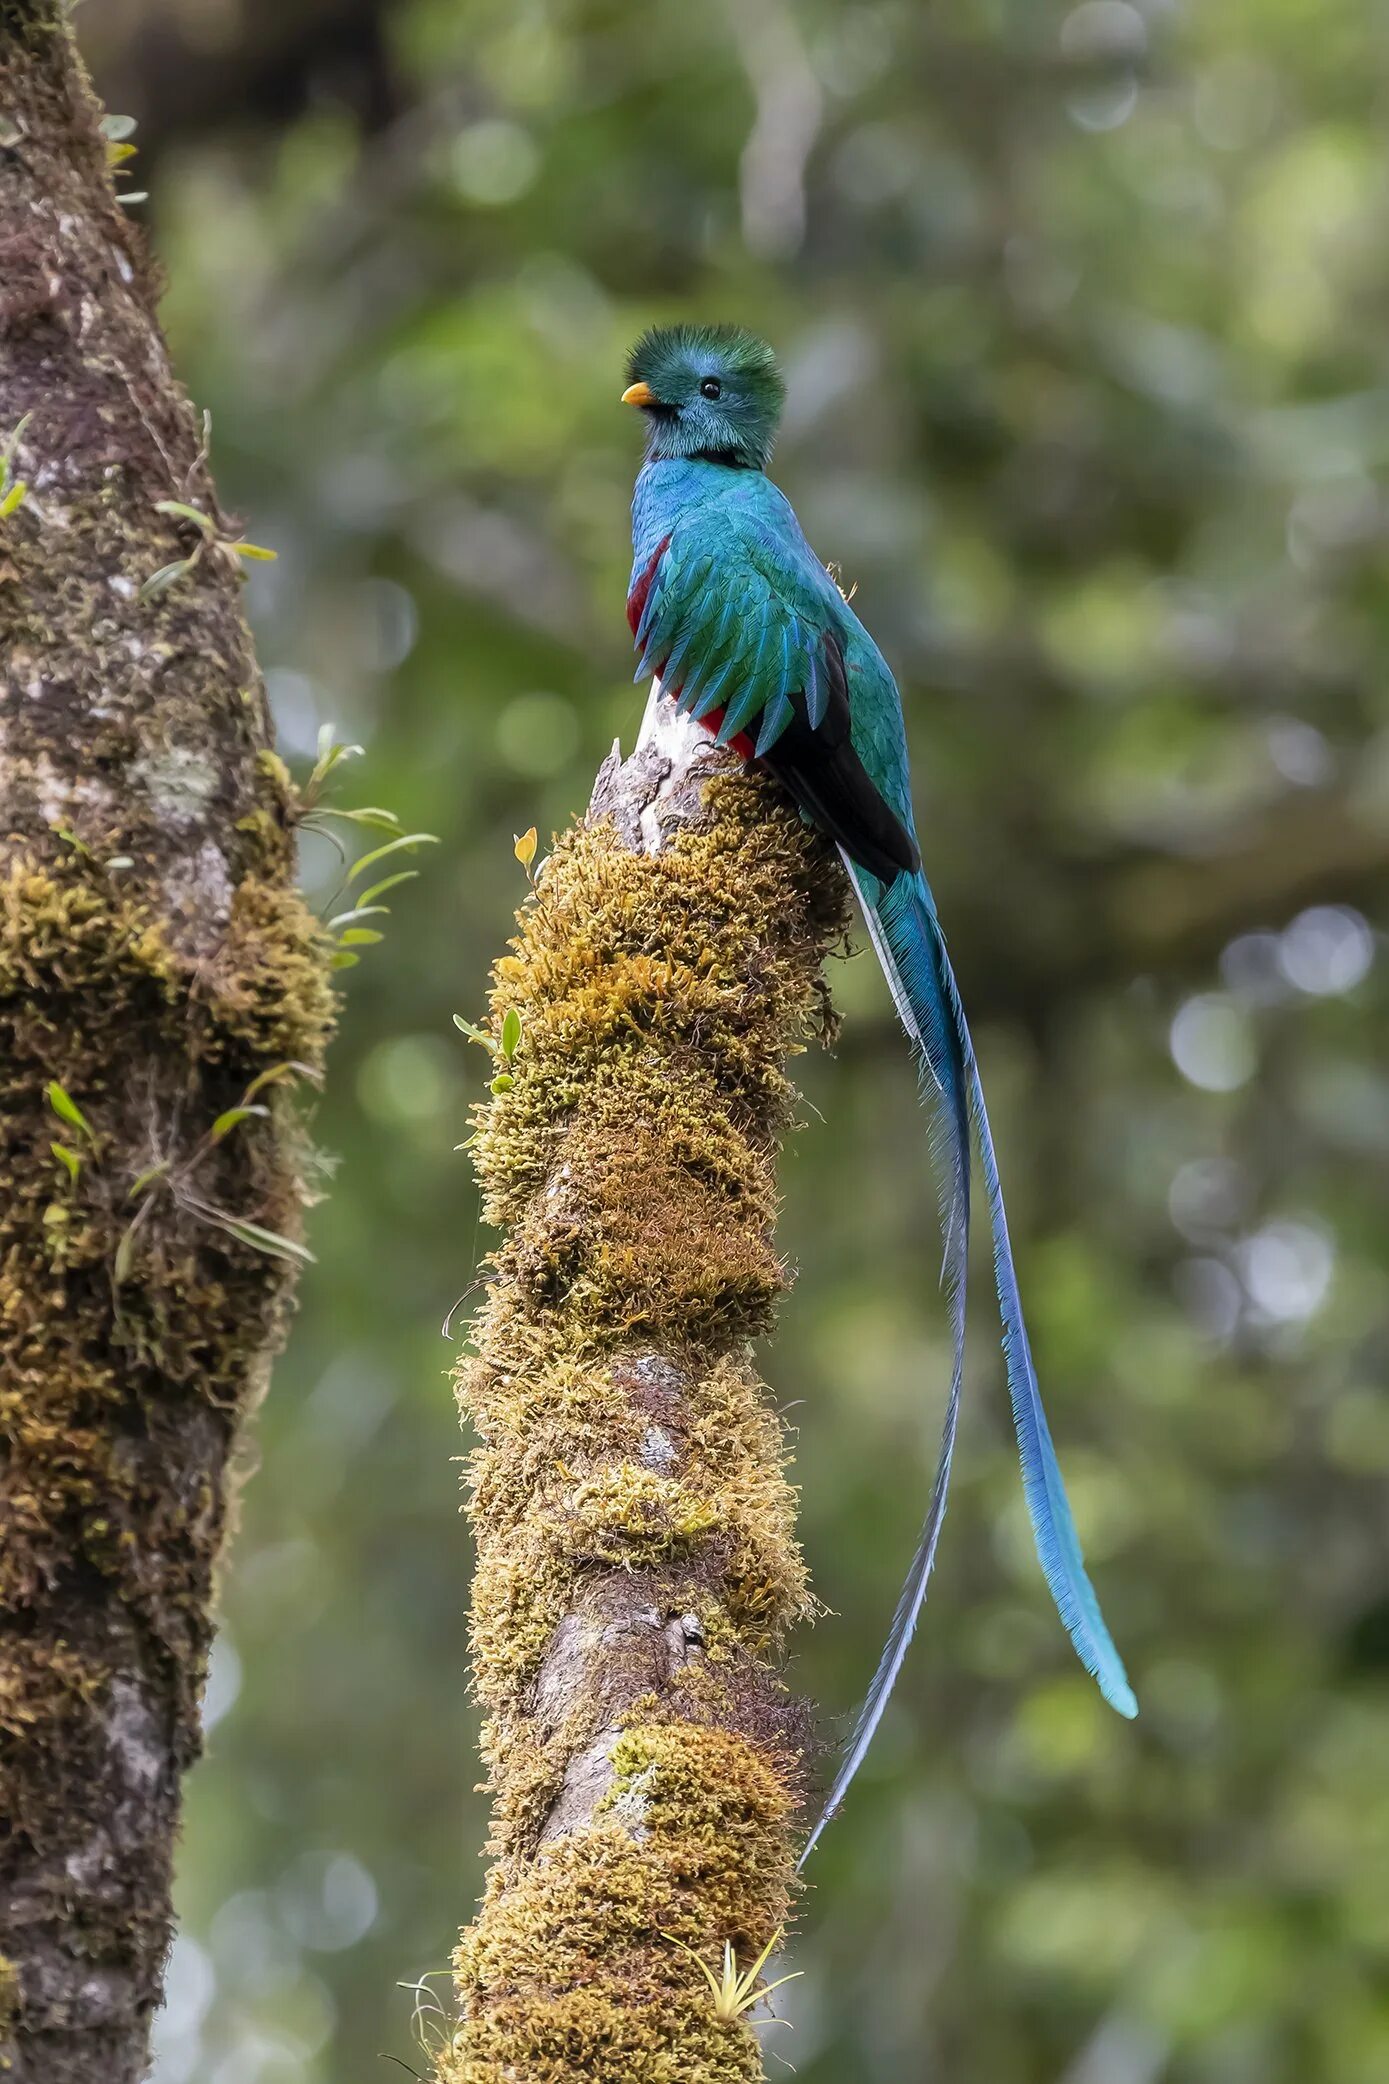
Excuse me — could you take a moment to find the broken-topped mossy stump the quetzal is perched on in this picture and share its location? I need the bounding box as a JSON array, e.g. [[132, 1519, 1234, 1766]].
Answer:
[[439, 702, 843, 2084]]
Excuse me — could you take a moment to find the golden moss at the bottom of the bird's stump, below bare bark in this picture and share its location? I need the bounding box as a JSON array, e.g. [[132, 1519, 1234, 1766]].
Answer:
[[439, 1723, 791, 2084]]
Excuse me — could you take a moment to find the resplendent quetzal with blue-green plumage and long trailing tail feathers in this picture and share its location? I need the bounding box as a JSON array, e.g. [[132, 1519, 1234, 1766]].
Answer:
[[623, 325, 1137, 1857]]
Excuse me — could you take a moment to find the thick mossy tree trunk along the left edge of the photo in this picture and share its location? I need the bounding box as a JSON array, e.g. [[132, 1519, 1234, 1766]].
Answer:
[[0, 0, 331, 2084]]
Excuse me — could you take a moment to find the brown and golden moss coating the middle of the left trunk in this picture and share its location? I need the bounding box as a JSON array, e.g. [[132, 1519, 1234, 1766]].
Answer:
[[0, 850, 333, 1875]]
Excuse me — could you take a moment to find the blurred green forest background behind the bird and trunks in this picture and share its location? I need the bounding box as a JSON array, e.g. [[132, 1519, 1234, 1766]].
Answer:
[[79, 0, 1389, 2084]]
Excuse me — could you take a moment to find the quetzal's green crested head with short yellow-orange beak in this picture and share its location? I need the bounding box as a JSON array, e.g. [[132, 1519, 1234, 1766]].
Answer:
[[623, 325, 785, 471]]
